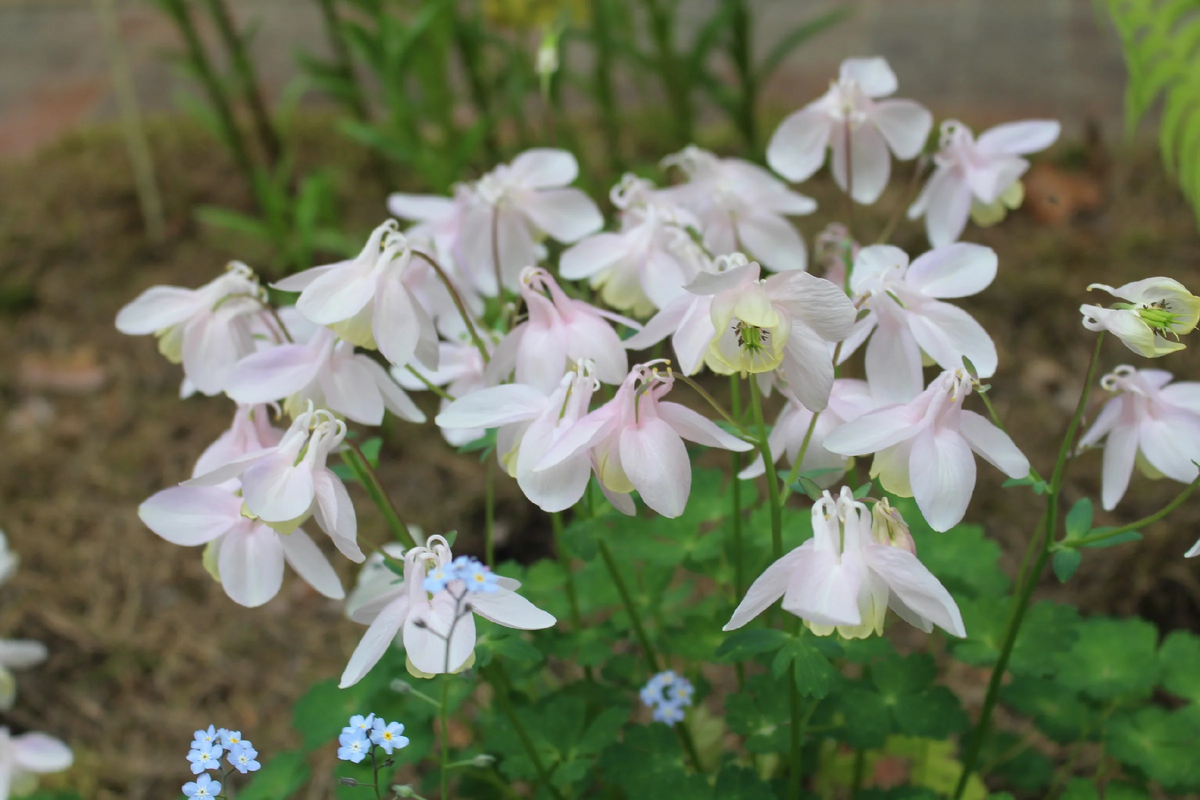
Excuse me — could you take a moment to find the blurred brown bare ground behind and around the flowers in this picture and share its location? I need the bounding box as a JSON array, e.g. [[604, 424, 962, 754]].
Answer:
[[0, 113, 1200, 800]]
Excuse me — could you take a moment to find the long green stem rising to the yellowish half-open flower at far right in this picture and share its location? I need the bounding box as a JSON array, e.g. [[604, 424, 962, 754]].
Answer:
[[954, 332, 1104, 800]]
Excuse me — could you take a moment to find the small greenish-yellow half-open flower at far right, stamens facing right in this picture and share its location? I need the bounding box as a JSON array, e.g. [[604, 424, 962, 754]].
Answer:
[[1079, 278, 1200, 359]]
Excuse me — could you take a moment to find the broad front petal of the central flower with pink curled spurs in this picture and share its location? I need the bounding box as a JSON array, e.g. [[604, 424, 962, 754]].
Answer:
[[620, 417, 691, 517]]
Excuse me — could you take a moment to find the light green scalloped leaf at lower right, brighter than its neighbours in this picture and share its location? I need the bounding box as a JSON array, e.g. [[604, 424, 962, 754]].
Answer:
[[1057, 618, 1158, 700]]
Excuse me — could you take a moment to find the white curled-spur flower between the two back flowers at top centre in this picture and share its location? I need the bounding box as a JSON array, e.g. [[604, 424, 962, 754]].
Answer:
[[558, 174, 700, 317]]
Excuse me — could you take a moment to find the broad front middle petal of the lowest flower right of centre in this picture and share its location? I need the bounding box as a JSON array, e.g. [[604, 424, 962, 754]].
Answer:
[[784, 548, 864, 625]]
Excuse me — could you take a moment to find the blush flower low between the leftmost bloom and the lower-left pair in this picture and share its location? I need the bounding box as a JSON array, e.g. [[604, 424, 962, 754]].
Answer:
[[226, 327, 425, 425]]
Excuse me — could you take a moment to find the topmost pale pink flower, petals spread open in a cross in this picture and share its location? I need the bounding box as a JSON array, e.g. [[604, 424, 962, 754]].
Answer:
[[767, 58, 934, 205]]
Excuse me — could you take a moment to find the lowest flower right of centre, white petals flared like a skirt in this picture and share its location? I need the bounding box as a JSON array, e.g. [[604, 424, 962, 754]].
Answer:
[[724, 486, 966, 639]]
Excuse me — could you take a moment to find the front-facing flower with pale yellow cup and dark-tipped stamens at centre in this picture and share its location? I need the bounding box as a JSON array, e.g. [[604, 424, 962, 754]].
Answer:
[[688, 255, 856, 411]]
